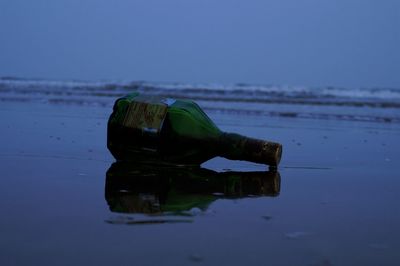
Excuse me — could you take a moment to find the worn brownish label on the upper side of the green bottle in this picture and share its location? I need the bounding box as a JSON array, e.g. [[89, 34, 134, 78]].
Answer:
[[123, 96, 168, 134]]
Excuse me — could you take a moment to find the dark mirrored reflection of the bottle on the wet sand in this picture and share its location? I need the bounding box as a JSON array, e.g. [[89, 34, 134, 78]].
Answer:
[[105, 162, 280, 213]]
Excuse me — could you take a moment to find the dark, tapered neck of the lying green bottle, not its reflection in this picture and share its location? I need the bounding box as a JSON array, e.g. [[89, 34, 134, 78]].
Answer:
[[219, 133, 282, 167]]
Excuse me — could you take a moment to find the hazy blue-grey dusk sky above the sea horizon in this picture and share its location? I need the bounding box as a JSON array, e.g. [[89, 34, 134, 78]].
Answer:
[[0, 0, 400, 87]]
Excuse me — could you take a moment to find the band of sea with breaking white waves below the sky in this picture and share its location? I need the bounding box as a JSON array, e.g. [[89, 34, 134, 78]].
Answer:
[[0, 77, 400, 123]]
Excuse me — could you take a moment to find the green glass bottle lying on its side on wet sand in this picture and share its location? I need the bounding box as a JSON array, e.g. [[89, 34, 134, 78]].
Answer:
[[107, 93, 282, 166]]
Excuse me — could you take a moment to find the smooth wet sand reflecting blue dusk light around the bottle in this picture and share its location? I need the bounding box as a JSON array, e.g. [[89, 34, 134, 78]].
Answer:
[[0, 101, 400, 265]]
